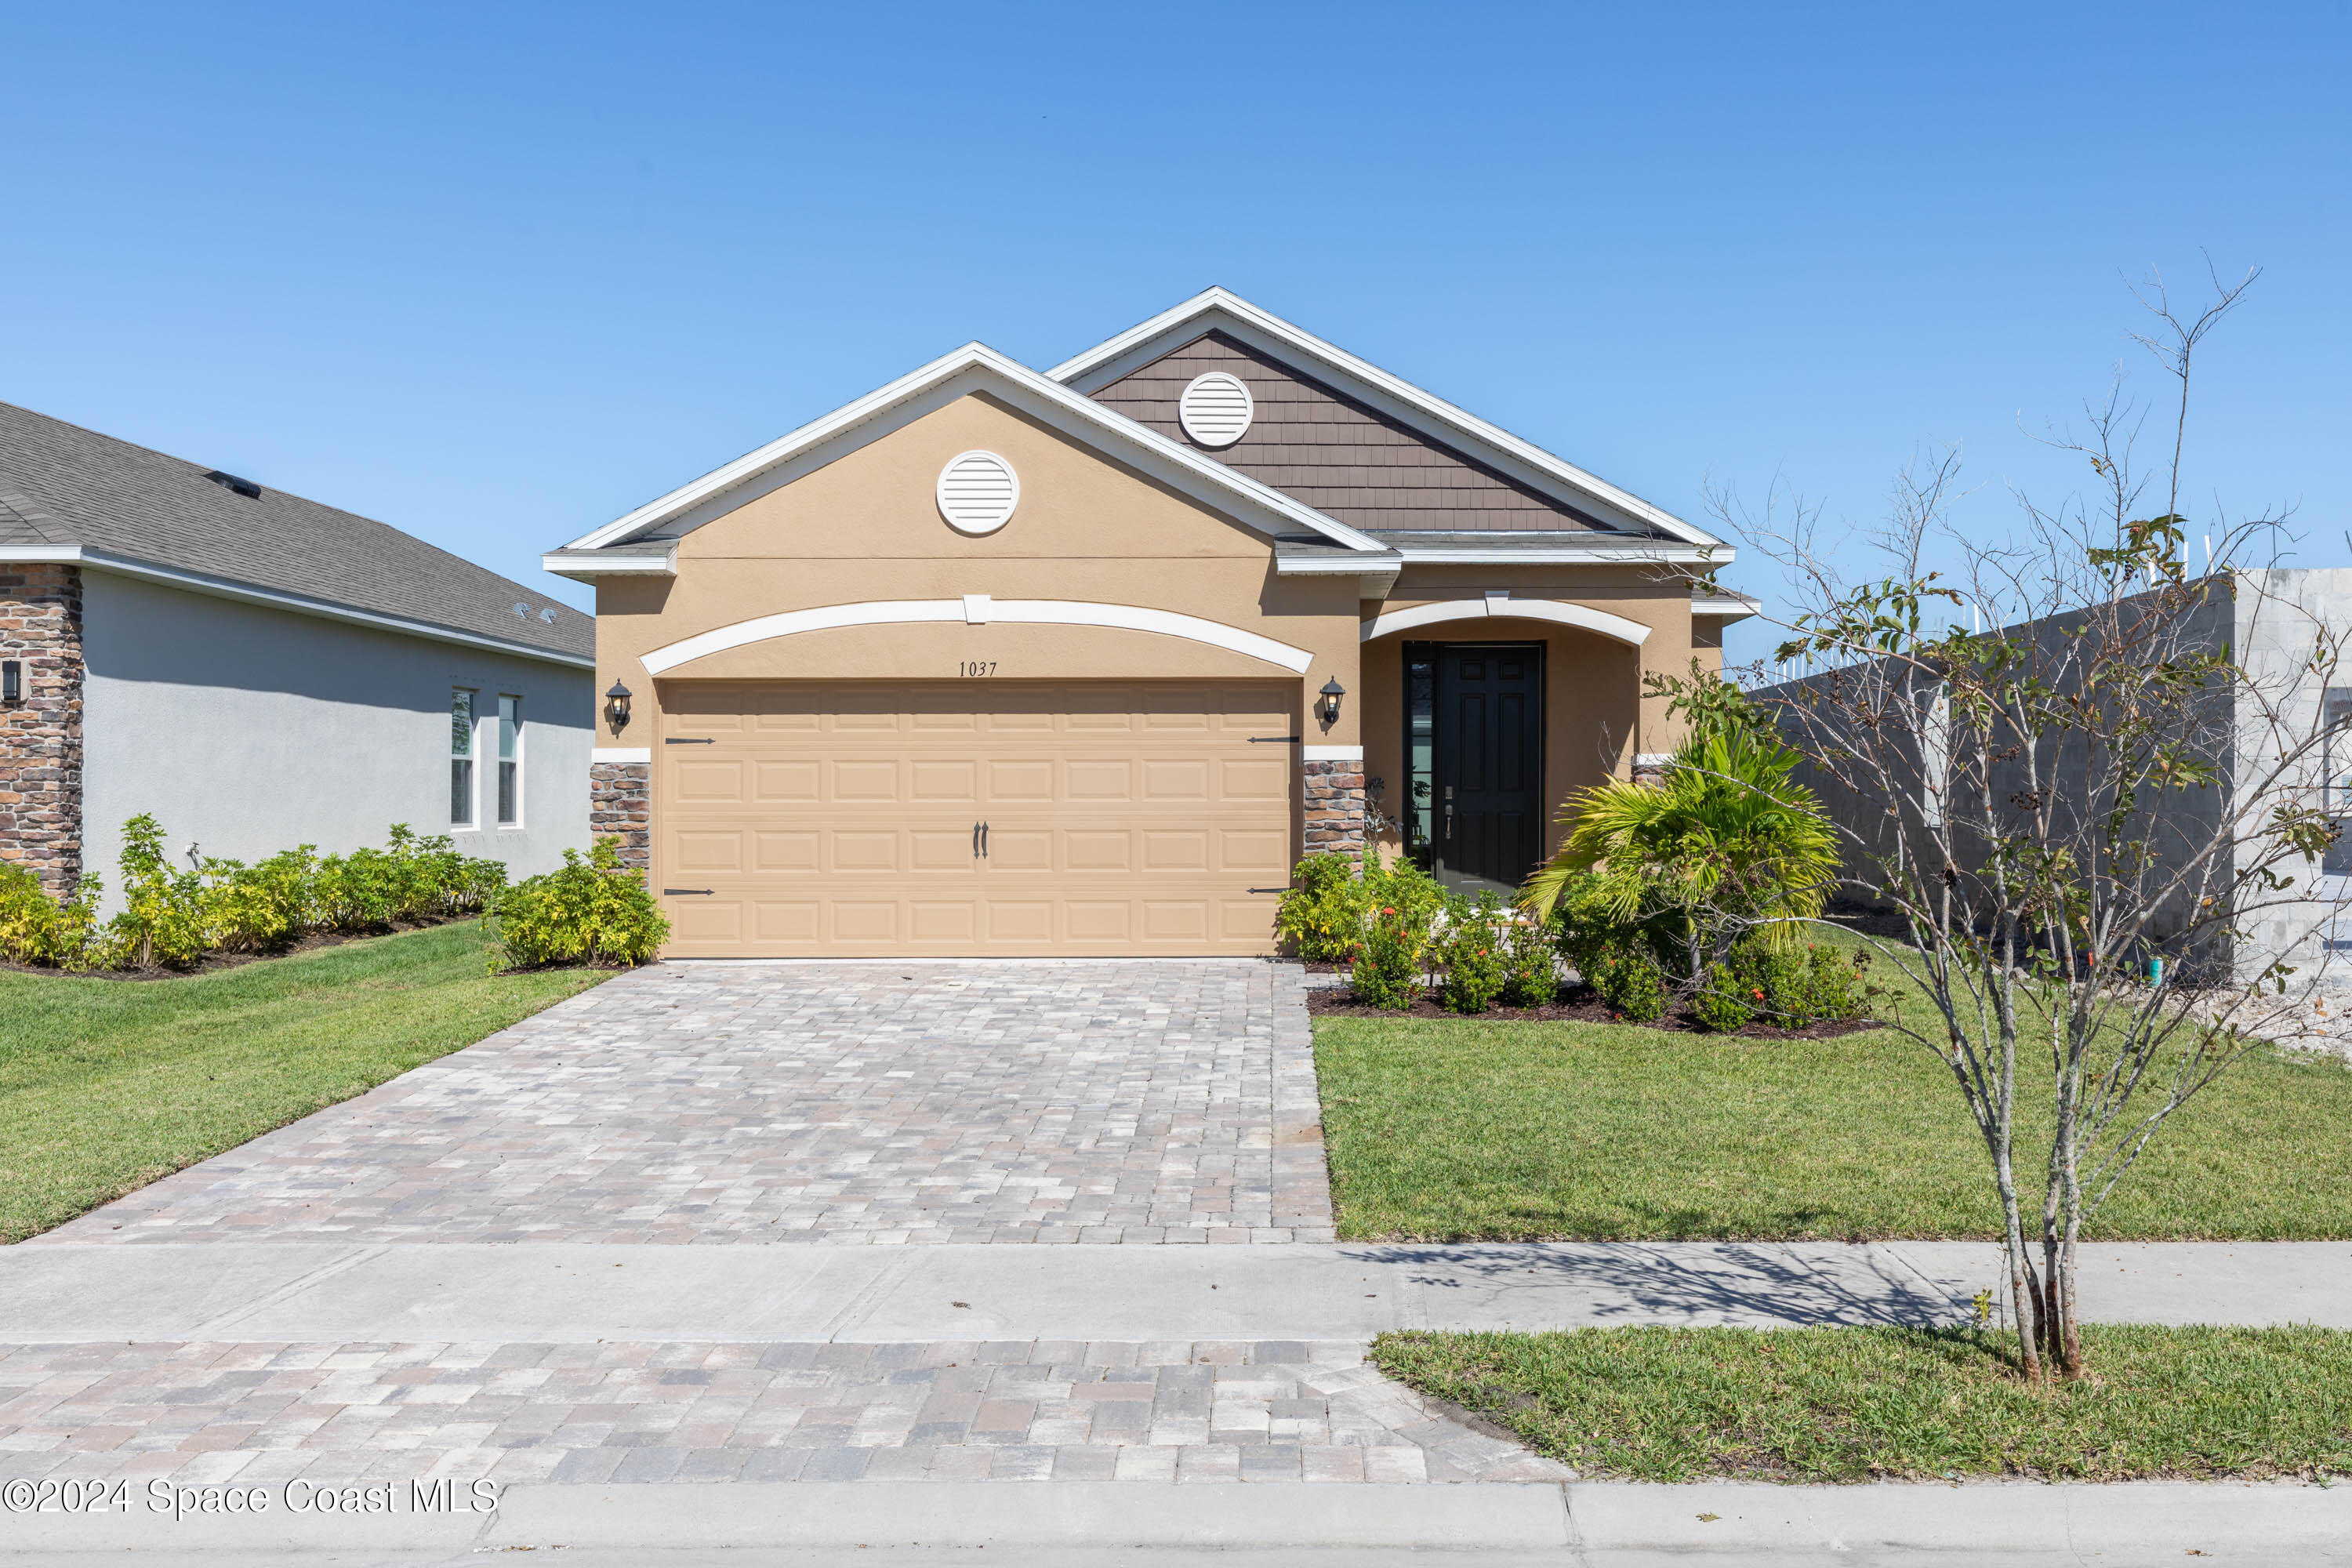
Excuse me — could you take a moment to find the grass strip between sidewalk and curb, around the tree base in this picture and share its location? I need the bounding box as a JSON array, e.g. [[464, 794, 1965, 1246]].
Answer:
[[1371, 1326, 2352, 1483]]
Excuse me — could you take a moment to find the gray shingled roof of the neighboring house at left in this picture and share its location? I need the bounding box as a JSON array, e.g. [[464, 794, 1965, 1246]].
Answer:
[[0, 402, 595, 668]]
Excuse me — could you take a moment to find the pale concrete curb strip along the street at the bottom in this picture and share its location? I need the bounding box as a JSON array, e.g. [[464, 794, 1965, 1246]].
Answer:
[[0, 1481, 2352, 1568]]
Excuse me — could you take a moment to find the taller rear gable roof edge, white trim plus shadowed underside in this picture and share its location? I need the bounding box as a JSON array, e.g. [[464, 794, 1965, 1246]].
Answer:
[[1047, 289, 1731, 560]]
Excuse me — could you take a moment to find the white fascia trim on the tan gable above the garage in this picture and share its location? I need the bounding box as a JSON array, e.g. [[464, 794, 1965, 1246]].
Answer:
[[564, 343, 1383, 553]]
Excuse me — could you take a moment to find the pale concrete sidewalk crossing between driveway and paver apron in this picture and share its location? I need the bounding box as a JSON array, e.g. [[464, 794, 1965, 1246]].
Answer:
[[0, 1241, 2352, 1345]]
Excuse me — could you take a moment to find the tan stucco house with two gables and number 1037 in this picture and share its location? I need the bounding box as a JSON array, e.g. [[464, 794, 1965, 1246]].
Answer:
[[546, 289, 1752, 956]]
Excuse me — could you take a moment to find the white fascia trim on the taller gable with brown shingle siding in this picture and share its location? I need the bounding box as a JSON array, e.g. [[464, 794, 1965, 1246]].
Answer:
[[1047, 289, 1715, 546]]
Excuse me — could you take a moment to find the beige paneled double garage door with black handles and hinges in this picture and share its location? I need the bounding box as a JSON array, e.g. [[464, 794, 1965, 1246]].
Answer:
[[654, 680, 1298, 956]]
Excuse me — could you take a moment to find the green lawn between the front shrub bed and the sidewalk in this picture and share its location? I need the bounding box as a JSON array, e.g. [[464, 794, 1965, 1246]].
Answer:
[[1315, 1018, 2352, 1241]]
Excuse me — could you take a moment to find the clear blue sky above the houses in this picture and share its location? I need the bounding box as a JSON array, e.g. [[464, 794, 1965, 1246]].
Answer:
[[0, 0, 2352, 654]]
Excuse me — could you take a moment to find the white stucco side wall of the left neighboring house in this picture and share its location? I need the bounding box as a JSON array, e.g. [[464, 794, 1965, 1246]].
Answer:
[[82, 572, 595, 905]]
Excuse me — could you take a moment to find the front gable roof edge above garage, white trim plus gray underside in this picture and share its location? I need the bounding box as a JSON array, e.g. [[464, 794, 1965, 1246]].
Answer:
[[546, 343, 1381, 576]]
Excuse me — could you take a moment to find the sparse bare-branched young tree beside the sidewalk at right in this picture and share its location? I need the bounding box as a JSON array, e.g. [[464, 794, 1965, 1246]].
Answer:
[[1726, 275, 2340, 1377]]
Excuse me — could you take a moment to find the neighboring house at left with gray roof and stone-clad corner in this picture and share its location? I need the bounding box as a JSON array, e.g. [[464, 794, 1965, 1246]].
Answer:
[[0, 405, 595, 888]]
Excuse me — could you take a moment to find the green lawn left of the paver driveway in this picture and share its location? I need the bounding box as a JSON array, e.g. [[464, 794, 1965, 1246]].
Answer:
[[0, 921, 607, 1241]]
